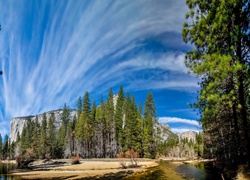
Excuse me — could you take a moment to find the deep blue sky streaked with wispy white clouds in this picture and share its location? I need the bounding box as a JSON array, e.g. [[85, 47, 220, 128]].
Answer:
[[0, 0, 201, 136]]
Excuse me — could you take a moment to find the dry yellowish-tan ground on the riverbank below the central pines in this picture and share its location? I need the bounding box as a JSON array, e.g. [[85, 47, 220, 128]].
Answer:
[[12, 159, 158, 179]]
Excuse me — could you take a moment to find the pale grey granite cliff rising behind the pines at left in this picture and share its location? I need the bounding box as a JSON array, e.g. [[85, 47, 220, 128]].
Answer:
[[10, 109, 77, 142]]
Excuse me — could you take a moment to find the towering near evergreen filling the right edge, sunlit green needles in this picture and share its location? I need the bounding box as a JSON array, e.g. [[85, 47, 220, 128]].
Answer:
[[182, 0, 250, 166]]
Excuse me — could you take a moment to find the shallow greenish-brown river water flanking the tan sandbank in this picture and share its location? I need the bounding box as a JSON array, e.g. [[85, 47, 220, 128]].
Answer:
[[0, 161, 221, 180]]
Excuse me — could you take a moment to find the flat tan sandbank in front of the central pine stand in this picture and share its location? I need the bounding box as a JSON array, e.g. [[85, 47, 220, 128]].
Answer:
[[11, 159, 158, 179]]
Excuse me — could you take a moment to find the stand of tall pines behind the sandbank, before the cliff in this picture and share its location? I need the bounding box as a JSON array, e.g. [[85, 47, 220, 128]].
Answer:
[[0, 86, 162, 159]]
